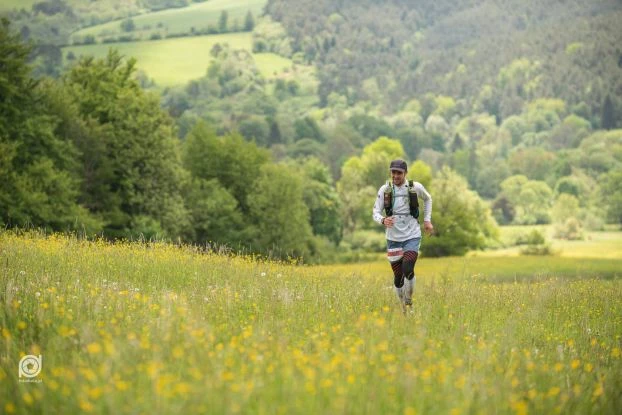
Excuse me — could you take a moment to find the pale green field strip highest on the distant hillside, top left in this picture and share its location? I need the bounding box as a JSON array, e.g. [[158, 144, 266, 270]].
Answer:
[[72, 0, 266, 39]]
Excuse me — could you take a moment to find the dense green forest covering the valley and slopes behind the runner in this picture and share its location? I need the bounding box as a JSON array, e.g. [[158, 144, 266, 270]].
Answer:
[[0, 0, 622, 261]]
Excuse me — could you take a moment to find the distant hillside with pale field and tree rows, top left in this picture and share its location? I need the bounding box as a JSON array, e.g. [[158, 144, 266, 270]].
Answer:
[[0, 0, 266, 80]]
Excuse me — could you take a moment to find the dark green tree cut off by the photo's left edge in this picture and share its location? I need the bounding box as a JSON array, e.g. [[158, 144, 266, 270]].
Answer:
[[0, 20, 91, 230]]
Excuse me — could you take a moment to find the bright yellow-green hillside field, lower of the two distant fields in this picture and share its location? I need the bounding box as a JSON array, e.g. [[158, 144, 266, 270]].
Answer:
[[63, 33, 292, 86]]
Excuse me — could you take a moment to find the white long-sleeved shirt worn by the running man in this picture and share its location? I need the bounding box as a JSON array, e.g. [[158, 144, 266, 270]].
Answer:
[[373, 181, 432, 242]]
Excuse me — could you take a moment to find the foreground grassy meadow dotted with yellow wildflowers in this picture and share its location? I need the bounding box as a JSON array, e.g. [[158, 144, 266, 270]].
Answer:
[[0, 232, 622, 414]]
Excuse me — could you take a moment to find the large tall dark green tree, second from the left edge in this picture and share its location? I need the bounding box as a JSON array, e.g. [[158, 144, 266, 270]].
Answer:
[[63, 50, 187, 237]]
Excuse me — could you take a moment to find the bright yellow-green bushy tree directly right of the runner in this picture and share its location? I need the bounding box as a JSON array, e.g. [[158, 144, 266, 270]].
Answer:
[[422, 167, 497, 256]]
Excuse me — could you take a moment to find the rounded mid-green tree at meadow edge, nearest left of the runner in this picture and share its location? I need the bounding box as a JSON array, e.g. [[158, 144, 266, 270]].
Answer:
[[248, 164, 312, 258]]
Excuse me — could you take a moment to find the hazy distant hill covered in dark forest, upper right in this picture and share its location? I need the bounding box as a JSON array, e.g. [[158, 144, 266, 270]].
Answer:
[[266, 0, 622, 123]]
